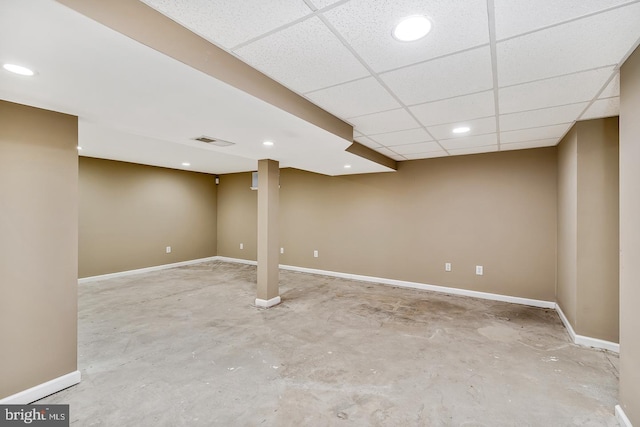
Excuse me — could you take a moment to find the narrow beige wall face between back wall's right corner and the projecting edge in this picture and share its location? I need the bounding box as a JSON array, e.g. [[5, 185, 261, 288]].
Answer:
[[556, 127, 578, 325]]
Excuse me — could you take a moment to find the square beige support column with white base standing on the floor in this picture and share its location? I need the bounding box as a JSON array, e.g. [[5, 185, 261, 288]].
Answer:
[[256, 159, 280, 308]]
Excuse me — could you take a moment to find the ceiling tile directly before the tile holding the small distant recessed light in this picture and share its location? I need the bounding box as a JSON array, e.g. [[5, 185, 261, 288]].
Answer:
[[409, 90, 496, 126]]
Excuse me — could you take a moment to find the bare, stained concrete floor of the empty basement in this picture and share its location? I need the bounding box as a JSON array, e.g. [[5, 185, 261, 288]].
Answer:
[[39, 262, 618, 426]]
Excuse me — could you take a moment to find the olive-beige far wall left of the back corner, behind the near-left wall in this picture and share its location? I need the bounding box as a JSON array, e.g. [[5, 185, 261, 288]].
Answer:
[[79, 157, 217, 277]]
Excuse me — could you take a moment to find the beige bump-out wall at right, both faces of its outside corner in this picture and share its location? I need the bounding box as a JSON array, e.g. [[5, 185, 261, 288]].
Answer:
[[556, 117, 619, 342]]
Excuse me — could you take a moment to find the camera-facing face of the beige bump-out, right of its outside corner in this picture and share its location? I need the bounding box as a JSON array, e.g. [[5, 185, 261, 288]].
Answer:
[[574, 117, 620, 343]]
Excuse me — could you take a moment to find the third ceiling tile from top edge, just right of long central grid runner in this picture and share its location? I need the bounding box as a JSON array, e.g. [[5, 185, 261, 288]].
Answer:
[[499, 67, 613, 114]]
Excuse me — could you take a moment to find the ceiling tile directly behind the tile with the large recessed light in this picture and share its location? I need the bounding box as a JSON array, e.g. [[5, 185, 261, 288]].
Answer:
[[380, 47, 493, 105]]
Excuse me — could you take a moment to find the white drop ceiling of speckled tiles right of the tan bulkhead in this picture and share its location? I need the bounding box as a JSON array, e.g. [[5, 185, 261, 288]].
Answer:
[[144, 0, 640, 160]]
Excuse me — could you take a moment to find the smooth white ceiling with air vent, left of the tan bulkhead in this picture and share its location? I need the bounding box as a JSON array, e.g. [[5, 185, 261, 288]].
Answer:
[[0, 0, 392, 175]]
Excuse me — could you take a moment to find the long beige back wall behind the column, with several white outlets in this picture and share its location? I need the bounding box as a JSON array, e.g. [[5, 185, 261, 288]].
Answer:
[[218, 148, 557, 301]]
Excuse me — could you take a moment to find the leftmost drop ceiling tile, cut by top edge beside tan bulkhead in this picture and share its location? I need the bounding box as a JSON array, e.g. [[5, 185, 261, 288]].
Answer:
[[142, 0, 311, 49]]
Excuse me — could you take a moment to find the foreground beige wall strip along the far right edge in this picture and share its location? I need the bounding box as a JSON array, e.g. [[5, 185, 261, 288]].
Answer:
[[620, 45, 640, 426]]
